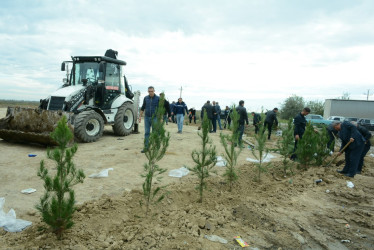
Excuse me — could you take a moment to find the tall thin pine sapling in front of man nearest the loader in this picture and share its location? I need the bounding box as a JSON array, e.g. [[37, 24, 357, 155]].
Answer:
[[141, 94, 170, 215]]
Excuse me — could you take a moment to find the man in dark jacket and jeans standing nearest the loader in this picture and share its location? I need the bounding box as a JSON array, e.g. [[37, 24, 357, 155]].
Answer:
[[139, 86, 160, 153]]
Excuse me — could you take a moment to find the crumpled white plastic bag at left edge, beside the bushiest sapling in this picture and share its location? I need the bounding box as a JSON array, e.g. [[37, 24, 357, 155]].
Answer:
[[0, 197, 32, 233]]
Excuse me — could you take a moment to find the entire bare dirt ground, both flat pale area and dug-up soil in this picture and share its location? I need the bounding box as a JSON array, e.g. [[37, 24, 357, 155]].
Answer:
[[0, 109, 374, 249]]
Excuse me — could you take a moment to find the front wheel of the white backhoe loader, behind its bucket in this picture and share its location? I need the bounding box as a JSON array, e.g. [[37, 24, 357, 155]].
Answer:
[[74, 110, 104, 142]]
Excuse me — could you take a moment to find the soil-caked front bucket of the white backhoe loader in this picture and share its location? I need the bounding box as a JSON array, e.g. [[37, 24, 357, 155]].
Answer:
[[0, 107, 73, 145]]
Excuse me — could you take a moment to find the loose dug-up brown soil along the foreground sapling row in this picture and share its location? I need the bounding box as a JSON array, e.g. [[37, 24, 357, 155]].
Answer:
[[0, 159, 374, 249]]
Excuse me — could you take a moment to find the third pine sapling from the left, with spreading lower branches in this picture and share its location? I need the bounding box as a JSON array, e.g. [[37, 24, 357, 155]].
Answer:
[[189, 110, 217, 203]]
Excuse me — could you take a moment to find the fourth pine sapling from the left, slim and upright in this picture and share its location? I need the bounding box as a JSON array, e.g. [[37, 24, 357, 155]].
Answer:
[[220, 107, 242, 192]]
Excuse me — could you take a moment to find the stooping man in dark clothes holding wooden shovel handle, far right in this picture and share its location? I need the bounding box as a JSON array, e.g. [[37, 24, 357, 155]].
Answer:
[[333, 122, 365, 177]]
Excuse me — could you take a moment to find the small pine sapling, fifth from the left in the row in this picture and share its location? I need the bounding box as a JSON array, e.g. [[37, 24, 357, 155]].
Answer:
[[252, 124, 269, 181]]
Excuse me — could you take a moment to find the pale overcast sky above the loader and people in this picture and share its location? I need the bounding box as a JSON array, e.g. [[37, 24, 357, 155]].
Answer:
[[0, 0, 374, 111]]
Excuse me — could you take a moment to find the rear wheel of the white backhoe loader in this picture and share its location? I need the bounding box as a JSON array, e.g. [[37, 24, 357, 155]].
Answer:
[[113, 102, 135, 136]]
